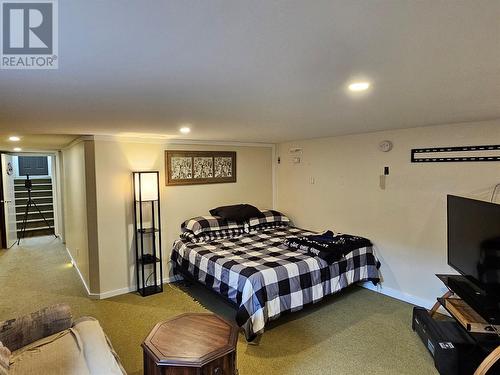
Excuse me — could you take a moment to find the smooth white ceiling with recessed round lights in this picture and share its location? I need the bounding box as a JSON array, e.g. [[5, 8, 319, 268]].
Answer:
[[0, 0, 500, 142]]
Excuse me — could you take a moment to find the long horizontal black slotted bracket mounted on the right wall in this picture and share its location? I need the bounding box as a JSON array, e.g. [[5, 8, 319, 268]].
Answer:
[[411, 145, 500, 163]]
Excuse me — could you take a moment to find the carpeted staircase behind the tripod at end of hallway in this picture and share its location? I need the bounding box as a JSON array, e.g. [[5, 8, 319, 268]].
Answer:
[[14, 178, 54, 237]]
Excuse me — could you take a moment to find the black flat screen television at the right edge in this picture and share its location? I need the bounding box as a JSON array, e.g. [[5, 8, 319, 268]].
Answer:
[[448, 195, 500, 298]]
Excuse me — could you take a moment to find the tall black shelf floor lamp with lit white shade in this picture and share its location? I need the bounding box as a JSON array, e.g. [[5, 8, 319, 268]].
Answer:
[[133, 171, 163, 297]]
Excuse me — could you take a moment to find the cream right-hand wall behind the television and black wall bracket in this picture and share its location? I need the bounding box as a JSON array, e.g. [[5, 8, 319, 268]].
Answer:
[[277, 121, 500, 304]]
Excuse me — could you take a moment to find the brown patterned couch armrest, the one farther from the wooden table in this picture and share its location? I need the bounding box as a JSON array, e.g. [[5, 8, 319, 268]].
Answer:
[[0, 304, 73, 352]]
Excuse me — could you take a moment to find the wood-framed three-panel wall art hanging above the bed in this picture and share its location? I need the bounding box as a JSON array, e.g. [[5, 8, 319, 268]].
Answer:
[[165, 150, 236, 185]]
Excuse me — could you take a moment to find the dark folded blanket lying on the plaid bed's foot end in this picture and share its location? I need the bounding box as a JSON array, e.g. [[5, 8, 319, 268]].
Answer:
[[284, 230, 372, 264]]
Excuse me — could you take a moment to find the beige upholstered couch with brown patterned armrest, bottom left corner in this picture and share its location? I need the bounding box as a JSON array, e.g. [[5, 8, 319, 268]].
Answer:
[[0, 304, 126, 375]]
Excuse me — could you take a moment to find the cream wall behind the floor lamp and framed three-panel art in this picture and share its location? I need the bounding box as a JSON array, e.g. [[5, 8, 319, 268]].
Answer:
[[95, 140, 272, 297]]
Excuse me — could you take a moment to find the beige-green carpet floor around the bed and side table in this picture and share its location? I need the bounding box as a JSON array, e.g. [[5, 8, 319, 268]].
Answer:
[[0, 237, 437, 375]]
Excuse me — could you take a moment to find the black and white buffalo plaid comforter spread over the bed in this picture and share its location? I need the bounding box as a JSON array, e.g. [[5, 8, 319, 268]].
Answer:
[[171, 227, 380, 340]]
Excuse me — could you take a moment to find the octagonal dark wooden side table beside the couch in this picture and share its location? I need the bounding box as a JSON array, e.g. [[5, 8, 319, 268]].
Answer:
[[142, 313, 238, 375]]
